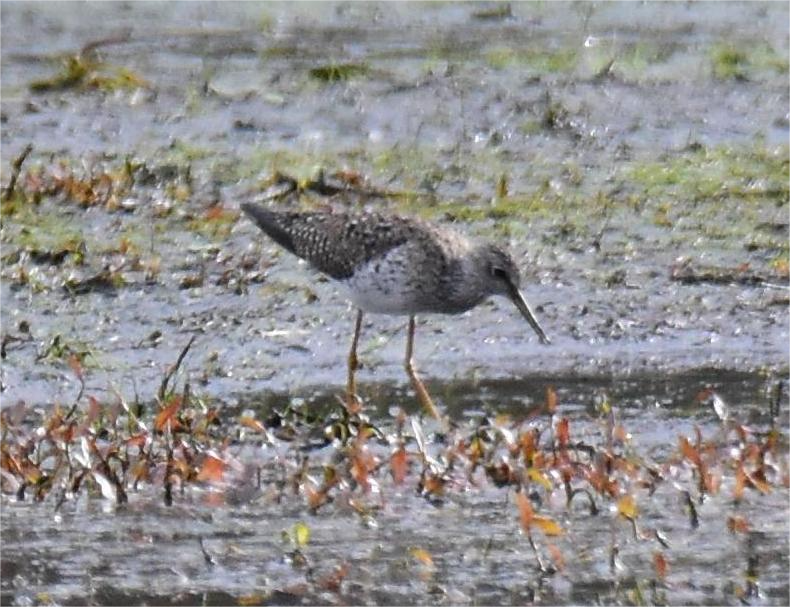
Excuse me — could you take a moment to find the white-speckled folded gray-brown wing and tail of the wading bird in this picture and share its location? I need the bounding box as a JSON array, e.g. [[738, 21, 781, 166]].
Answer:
[[241, 203, 427, 280]]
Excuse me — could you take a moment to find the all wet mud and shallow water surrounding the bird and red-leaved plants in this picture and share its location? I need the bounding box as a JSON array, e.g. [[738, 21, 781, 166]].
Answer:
[[0, 0, 790, 605]]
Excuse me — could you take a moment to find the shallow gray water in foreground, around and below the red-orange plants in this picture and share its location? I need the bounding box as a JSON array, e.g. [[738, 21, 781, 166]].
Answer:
[[0, 372, 790, 605]]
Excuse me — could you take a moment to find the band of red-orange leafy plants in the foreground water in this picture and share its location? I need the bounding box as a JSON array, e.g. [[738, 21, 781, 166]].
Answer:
[[0, 338, 790, 604]]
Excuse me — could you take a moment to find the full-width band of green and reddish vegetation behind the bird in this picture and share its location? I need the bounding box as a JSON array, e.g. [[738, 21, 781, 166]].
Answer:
[[0, 144, 790, 268]]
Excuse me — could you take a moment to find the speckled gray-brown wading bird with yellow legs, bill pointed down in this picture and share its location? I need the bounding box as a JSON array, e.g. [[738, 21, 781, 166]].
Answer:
[[241, 203, 550, 416]]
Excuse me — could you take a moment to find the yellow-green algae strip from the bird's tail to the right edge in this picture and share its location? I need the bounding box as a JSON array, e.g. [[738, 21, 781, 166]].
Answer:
[[215, 142, 790, 256]]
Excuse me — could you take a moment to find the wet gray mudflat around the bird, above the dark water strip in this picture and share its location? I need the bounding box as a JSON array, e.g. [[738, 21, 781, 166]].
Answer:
[[0, 2, 790, 403]]
